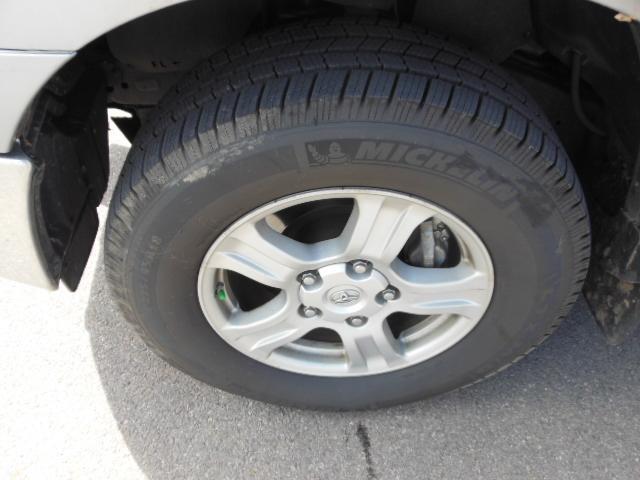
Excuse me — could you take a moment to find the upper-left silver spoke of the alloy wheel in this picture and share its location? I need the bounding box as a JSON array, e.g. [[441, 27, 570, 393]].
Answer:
[[209, 221, 313, 288]]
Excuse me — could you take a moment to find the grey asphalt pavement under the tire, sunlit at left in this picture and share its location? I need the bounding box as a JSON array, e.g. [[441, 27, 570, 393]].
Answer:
[[0, 124, 640, 480]]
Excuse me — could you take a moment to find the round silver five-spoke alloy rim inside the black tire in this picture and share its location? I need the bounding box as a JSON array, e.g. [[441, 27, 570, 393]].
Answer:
[[198, 189, 494, 376]]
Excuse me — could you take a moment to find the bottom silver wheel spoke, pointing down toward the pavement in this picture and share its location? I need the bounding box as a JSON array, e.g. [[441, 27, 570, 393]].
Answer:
[[340, 322, 405, 372]]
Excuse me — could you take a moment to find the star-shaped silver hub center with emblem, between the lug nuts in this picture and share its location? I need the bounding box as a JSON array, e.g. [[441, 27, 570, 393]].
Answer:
[[299, 263, 388, 322]]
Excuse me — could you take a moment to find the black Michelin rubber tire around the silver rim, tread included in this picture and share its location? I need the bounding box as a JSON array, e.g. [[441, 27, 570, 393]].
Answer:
[[105, 19, 590, 409]]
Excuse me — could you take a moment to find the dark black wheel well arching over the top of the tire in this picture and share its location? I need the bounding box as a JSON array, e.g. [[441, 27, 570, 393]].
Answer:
[[22, 0, 640, 314]]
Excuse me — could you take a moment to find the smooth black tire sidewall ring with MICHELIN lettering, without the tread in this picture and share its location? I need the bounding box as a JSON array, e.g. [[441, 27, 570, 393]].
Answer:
[[124, 122, 575, 409]]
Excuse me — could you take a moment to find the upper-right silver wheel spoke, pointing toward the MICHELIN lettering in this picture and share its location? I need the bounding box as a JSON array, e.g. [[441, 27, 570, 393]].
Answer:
[[340, 194, 434, 263]]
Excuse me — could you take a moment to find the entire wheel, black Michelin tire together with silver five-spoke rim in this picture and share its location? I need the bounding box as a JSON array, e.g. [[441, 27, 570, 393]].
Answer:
[[105, 20, 590, 409]]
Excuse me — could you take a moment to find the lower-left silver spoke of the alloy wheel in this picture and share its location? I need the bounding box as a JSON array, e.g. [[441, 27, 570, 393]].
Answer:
[[222, 292, 313, 358]]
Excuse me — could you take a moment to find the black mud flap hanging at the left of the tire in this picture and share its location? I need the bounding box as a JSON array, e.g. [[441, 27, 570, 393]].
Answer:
[[20, 58, 109, 290]]
